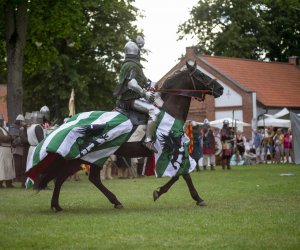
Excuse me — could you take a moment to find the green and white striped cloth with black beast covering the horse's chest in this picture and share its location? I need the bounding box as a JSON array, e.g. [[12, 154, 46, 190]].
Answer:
[[155, 112, 196, 177]]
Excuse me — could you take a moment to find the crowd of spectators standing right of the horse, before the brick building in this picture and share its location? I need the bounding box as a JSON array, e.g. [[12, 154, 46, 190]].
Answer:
[[185, 119, 294, 171]]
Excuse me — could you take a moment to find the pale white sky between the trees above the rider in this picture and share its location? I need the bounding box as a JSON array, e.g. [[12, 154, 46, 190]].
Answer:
[[135, 0, 198, 82]]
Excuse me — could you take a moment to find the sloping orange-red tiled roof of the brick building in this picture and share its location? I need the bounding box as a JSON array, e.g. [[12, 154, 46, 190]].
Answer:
[[201, 55, 300, 107]]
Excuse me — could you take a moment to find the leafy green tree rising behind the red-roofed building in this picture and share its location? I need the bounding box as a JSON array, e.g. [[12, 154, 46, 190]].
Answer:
[[178, 0, 300, 61]]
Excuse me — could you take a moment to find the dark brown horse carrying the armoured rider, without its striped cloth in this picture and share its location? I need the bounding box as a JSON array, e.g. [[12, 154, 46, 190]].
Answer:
[[29, 60, 223, 211]]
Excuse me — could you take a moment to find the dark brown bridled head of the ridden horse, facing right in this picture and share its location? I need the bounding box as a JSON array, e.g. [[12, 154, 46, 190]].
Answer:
[[186, 62, 224, 99]]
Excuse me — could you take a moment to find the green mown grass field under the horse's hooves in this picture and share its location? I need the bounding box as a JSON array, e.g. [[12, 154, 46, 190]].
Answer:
[[0, 165, 300, 250]]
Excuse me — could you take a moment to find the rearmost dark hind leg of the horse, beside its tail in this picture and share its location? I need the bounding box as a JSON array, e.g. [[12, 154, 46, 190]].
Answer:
[[51, 160, 80, 212]]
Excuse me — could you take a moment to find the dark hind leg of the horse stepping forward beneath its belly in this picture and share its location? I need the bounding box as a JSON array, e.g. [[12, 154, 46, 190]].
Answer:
[[89, 165, 123, 208]]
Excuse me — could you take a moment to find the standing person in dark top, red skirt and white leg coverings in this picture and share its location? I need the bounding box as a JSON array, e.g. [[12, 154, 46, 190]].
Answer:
[[203, 119, 216, 170]]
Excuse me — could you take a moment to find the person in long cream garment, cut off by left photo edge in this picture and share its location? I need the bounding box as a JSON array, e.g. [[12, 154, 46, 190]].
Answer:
[[0, 113, 16, 188]]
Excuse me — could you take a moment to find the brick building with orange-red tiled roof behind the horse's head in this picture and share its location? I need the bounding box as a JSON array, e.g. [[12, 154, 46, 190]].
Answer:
[[160, 47, 300, 136]]
